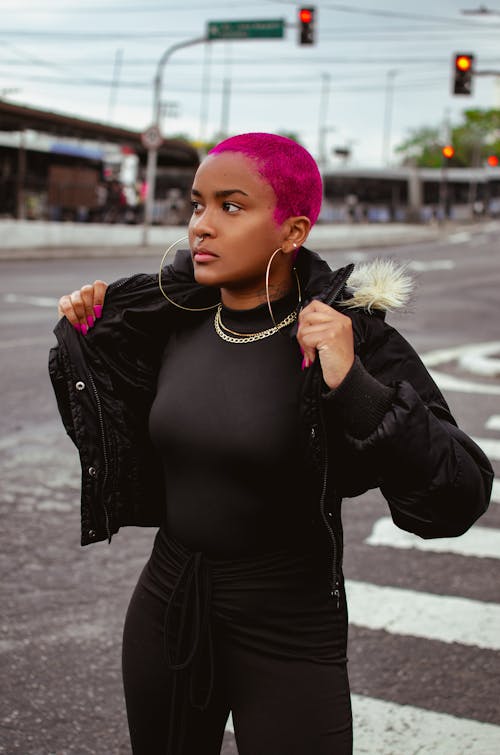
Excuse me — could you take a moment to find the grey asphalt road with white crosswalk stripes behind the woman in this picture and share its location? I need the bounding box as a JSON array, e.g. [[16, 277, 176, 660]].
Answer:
[[0, 226, 500, 755]]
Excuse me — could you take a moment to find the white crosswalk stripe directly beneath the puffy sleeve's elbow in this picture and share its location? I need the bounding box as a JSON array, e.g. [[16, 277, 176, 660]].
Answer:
[[365, 516, 500, 560]]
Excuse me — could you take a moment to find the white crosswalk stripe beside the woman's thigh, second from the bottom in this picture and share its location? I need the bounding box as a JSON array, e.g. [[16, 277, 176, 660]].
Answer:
[[346, 580, 500, 650]]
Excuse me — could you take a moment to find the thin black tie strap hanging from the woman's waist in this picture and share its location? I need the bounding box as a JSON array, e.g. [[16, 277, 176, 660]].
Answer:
[[163, 553, 214, 755]]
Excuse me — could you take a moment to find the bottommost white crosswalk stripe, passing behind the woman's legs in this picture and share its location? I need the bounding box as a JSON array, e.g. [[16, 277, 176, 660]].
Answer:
[[225, 694, 500, 755]]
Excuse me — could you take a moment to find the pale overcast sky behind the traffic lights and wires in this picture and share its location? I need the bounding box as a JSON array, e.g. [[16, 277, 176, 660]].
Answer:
[[0, 0, 500, 166]]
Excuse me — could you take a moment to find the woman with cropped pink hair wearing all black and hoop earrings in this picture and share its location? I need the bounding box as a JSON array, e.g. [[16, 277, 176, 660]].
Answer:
[[50, 133, 492, 755]]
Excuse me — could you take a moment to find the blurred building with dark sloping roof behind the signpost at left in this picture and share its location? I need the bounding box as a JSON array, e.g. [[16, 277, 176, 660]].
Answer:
[[0, 100, 199, 224]]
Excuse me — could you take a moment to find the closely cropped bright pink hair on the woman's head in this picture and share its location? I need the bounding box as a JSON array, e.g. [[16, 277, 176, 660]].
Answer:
[[208, 132, 323, 225]]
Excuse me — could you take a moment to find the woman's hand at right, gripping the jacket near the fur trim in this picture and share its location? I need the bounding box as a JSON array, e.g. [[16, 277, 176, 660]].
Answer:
[[297, 300, 354, 390]]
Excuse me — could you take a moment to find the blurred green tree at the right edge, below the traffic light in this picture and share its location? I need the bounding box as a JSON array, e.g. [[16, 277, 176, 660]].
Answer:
[[396, 109, 500, 168]]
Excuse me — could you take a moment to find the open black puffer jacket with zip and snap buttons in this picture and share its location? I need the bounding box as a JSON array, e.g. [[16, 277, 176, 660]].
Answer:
[[49, 248, 493, 592]]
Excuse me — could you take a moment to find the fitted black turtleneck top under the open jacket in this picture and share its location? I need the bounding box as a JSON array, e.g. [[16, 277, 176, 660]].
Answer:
[[149, 293, 311, 558]]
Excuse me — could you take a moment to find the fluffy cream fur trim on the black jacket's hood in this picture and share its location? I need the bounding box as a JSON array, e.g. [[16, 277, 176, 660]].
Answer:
[[342, 259, 413, 312]]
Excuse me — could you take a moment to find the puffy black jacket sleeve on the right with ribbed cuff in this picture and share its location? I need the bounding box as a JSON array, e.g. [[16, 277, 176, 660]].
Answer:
[[323, 315, 493, 538]]
